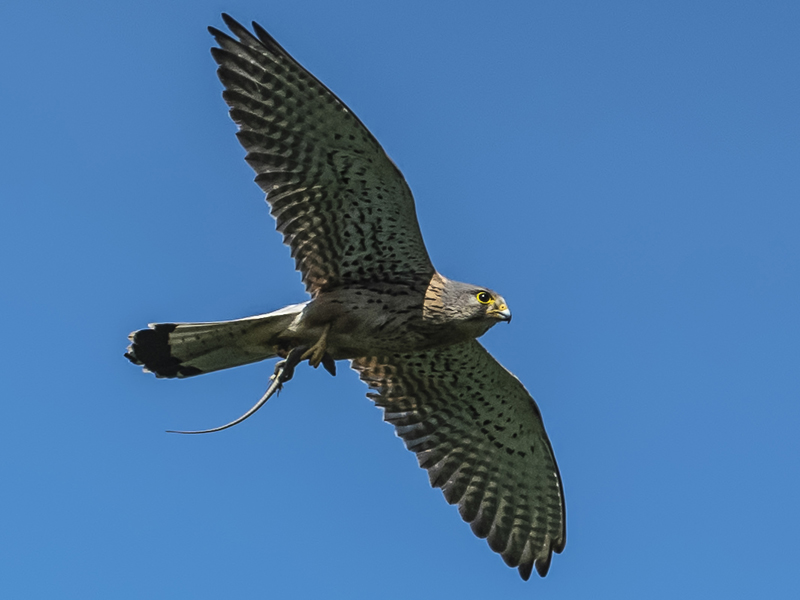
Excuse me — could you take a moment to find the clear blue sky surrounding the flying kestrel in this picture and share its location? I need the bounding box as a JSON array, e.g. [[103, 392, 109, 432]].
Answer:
[[0, 0, 800, 599]]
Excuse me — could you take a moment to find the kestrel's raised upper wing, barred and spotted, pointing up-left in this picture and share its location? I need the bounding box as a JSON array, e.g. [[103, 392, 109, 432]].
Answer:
[[209, 15, 434, 296]]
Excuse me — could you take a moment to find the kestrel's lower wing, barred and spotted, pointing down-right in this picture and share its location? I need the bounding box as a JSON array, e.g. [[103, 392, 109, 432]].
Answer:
[[352, 340, 566, 580]]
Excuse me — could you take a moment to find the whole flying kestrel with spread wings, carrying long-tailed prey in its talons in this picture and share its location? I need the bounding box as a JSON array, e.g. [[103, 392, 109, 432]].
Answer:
[[125, 15, 566, 580]]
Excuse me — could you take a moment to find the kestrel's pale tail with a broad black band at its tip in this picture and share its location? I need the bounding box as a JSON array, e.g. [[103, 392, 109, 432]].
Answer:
[[125, 303, 305, 377]]
